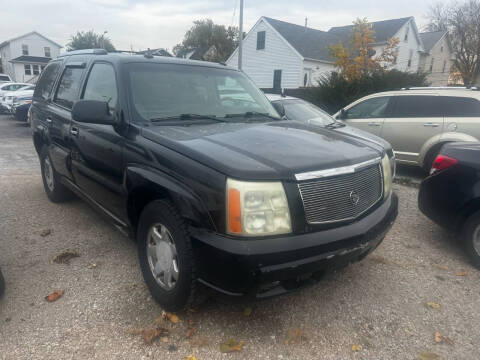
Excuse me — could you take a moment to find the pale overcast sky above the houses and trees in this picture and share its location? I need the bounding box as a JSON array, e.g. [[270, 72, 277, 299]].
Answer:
[[0, 0, 434, 50]]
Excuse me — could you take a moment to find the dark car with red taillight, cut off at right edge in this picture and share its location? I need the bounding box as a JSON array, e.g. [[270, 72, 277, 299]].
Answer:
[[418, 142, 480, 268]]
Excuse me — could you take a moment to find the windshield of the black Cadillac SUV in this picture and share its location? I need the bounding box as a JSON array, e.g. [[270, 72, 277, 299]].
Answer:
[[128, 63, 278, 121]]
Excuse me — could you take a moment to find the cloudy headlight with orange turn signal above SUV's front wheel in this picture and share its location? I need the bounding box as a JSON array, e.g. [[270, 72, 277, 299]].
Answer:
[[226, 179, 292, 236]]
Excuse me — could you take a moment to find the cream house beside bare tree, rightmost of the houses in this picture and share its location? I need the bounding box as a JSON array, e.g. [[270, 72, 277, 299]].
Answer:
[[420, 30, 453, 86]]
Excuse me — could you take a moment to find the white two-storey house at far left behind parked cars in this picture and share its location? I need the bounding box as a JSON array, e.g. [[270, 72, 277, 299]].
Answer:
[[0, 31, 62, 82]]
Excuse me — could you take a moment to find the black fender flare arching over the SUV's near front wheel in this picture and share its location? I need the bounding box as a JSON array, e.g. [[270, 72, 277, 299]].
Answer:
[[124, 165, 216, 231]]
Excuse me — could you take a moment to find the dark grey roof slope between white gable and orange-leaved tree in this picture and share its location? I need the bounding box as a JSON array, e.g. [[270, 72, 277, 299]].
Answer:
[[264, 17, 342, 62]]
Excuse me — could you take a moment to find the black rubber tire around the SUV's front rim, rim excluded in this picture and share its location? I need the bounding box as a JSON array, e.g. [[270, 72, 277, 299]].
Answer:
[[137, 200, 198, 311]]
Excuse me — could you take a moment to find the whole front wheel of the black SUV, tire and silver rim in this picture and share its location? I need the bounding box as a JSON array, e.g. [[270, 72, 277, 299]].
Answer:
[[137, 200, 198, 312]]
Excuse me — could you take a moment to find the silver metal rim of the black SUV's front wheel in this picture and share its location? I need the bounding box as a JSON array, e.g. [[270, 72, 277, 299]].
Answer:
[[147, 224, 179, 290]]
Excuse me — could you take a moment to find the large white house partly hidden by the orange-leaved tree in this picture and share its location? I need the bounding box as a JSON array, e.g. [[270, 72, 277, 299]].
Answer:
[[227, 17, 424, 88]]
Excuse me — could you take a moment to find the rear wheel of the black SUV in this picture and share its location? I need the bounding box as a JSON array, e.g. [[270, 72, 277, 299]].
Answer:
[[40, 146, 73, 203]]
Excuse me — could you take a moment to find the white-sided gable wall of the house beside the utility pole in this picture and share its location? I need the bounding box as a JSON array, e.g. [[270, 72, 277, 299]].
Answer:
[[227, 19, 303, 88]]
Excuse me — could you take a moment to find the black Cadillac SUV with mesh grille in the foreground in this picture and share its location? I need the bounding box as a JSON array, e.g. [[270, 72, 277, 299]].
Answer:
[[29, 49, 397, 311]]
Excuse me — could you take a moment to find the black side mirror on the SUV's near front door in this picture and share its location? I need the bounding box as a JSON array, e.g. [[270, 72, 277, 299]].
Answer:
[[72, 100, 116, 125]]
